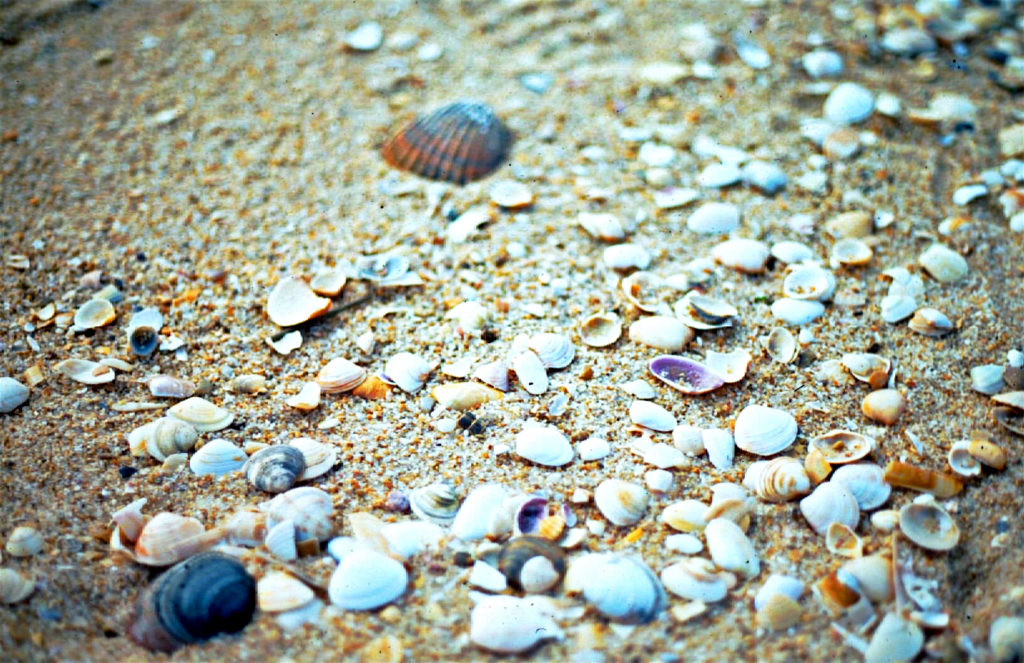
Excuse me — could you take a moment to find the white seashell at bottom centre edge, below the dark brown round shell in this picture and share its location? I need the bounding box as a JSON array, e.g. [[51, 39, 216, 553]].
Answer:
[[469, 595, 564, 654]]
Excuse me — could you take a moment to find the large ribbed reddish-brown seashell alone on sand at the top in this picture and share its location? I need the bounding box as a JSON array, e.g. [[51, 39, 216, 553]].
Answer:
[[381, 100, 512, 184]]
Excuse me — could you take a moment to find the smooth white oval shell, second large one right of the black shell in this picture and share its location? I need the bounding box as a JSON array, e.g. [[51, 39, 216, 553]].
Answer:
[[327, 549, 409, 610]]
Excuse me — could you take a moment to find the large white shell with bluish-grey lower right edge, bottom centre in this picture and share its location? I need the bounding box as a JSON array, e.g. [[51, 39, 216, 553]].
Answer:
[[581, 553, 668, 624]]
